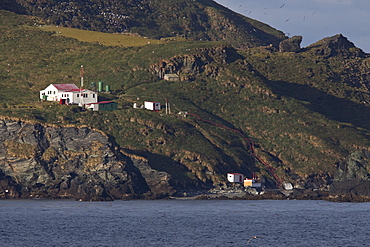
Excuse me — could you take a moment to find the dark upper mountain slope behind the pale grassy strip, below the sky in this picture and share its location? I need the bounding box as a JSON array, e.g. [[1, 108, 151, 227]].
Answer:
[[3, 0, 285, 47]]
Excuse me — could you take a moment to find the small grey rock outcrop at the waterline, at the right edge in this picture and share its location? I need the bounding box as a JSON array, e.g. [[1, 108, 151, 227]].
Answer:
[[330, 151, 370, 197]]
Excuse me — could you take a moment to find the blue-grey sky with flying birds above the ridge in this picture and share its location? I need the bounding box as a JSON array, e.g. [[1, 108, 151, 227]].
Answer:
[[215, 0, 370, 53]]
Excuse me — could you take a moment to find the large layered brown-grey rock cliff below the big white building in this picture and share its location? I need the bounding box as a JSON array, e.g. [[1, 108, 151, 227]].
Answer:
[[0, 120, 171, 200]]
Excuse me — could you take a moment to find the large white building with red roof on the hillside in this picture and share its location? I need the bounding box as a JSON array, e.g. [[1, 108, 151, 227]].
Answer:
[[40, 84, 98, 105]]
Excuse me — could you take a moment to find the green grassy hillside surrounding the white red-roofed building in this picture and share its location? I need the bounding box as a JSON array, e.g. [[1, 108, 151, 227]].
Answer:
[[0, 11, 370, 187]]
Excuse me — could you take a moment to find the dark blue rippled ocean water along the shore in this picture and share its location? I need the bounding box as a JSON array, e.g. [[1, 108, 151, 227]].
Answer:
[[0, 200, 370, 247]]
